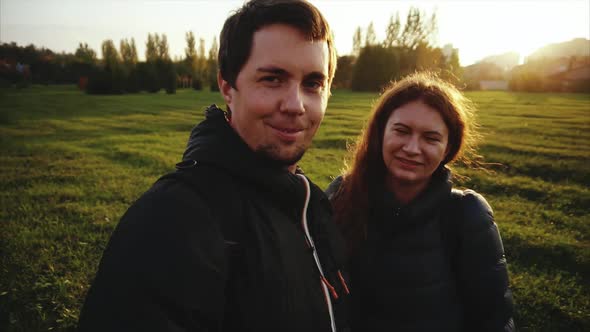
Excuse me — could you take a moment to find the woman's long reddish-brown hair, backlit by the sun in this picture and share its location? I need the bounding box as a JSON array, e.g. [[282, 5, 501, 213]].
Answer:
[[332, 72, 477, 253]]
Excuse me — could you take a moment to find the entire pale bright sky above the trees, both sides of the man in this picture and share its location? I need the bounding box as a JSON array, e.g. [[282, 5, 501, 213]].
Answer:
[[0, 0, 590, 66]]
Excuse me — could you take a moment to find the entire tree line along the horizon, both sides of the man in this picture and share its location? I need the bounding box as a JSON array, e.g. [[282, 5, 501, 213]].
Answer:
[[0, 7, 590, 94]]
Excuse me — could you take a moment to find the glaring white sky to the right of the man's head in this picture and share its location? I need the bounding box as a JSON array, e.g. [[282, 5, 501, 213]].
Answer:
[[314, 0, 590, 65]]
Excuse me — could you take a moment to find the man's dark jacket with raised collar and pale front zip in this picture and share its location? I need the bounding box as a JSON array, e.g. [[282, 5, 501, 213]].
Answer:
[[79, 105, 347, 331]]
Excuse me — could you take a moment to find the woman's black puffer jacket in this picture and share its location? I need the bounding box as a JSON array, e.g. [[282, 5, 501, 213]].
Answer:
[[327, 169, 514, 332]]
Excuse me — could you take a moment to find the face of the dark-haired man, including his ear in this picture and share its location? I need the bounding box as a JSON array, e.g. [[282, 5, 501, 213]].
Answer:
[[219, 24, 330, 166]]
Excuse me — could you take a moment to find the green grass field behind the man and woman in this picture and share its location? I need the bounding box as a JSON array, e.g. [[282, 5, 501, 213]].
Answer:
[[0, 86, 590, 331]]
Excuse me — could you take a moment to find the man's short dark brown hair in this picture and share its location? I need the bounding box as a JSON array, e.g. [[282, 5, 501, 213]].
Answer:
[[217, 0, 337, 89]]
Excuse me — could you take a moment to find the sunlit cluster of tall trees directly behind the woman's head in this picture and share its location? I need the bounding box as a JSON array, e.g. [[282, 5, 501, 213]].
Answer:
[[334, 7, 461, 91]]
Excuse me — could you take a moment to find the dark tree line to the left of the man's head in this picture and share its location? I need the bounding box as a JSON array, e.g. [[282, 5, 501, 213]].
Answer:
[[0, 31, 218, 94]]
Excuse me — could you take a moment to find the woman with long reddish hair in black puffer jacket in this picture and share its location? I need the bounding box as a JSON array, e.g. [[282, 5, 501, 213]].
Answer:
[[327, 73, 514, 332]]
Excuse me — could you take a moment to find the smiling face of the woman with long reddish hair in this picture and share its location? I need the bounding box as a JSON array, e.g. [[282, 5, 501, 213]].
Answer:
[[382, 101, 449, 190]]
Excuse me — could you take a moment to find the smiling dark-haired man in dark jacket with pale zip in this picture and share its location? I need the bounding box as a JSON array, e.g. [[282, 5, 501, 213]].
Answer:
[[79, 0, 348, 331]]
